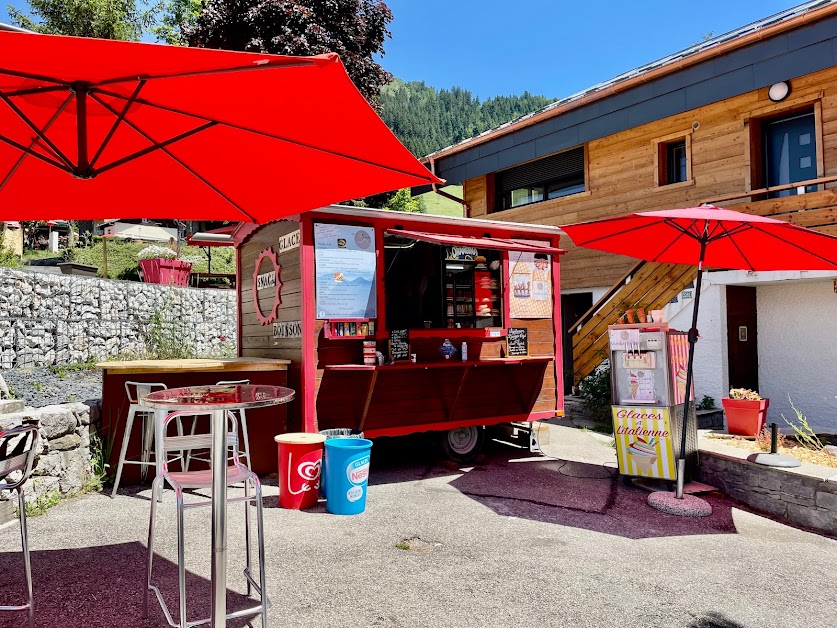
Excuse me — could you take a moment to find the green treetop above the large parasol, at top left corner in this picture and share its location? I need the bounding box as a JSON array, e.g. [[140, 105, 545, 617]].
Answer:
[[7, 0, 157, 40]]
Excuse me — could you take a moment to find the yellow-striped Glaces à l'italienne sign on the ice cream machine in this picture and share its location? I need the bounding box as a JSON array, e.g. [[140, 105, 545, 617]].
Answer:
[[613, 406, 677, 480]]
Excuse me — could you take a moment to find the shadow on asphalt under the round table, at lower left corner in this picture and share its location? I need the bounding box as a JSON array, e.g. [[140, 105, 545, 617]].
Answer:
[[0, 540, 257, 628]]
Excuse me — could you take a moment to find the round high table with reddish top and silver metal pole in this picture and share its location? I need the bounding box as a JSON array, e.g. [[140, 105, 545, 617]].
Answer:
[[142, 385, 296, 628]]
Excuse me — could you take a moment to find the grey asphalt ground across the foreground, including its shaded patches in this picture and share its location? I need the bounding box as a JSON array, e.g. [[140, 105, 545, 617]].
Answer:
[[0, 426, 837, 628]]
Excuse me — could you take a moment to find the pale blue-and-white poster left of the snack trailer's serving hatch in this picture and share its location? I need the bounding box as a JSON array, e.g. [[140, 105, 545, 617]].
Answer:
[[314, 223, 377, 319]]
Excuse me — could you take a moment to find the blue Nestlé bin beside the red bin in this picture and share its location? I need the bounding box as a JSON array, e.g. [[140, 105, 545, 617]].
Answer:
[[325, 438, 372, 515]]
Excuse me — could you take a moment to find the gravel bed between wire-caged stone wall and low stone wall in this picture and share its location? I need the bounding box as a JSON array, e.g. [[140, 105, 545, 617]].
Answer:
[[0, 367, 102, 408]]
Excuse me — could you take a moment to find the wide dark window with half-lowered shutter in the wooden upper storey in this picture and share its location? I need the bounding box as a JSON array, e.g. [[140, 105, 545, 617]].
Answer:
[[494, 146, 586, 210]]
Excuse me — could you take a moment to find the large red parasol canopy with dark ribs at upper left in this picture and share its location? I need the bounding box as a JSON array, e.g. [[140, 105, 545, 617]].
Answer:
[[0, 32, 440, 222]]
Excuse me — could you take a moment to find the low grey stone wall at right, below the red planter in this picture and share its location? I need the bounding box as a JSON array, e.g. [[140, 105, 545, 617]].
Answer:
[[700, 450, 837, 534]]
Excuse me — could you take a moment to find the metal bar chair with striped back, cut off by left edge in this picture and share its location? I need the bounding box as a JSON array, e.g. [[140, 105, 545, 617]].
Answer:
[[0, 425, 38, 628]]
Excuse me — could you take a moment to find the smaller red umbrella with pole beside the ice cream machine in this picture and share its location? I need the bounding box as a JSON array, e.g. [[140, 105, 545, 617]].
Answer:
[[562, 205, 837, 498]]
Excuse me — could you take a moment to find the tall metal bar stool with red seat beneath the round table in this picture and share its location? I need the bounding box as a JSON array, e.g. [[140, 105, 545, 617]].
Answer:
[[143, 412, 268, 628]]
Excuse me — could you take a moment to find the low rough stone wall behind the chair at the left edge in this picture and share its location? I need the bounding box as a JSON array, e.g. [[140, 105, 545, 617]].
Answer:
[[0, 401, 101, 523]]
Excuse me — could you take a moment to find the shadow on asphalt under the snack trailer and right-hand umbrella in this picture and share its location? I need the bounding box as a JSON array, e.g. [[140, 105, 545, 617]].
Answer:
[[370, 435, 741, 539]]
